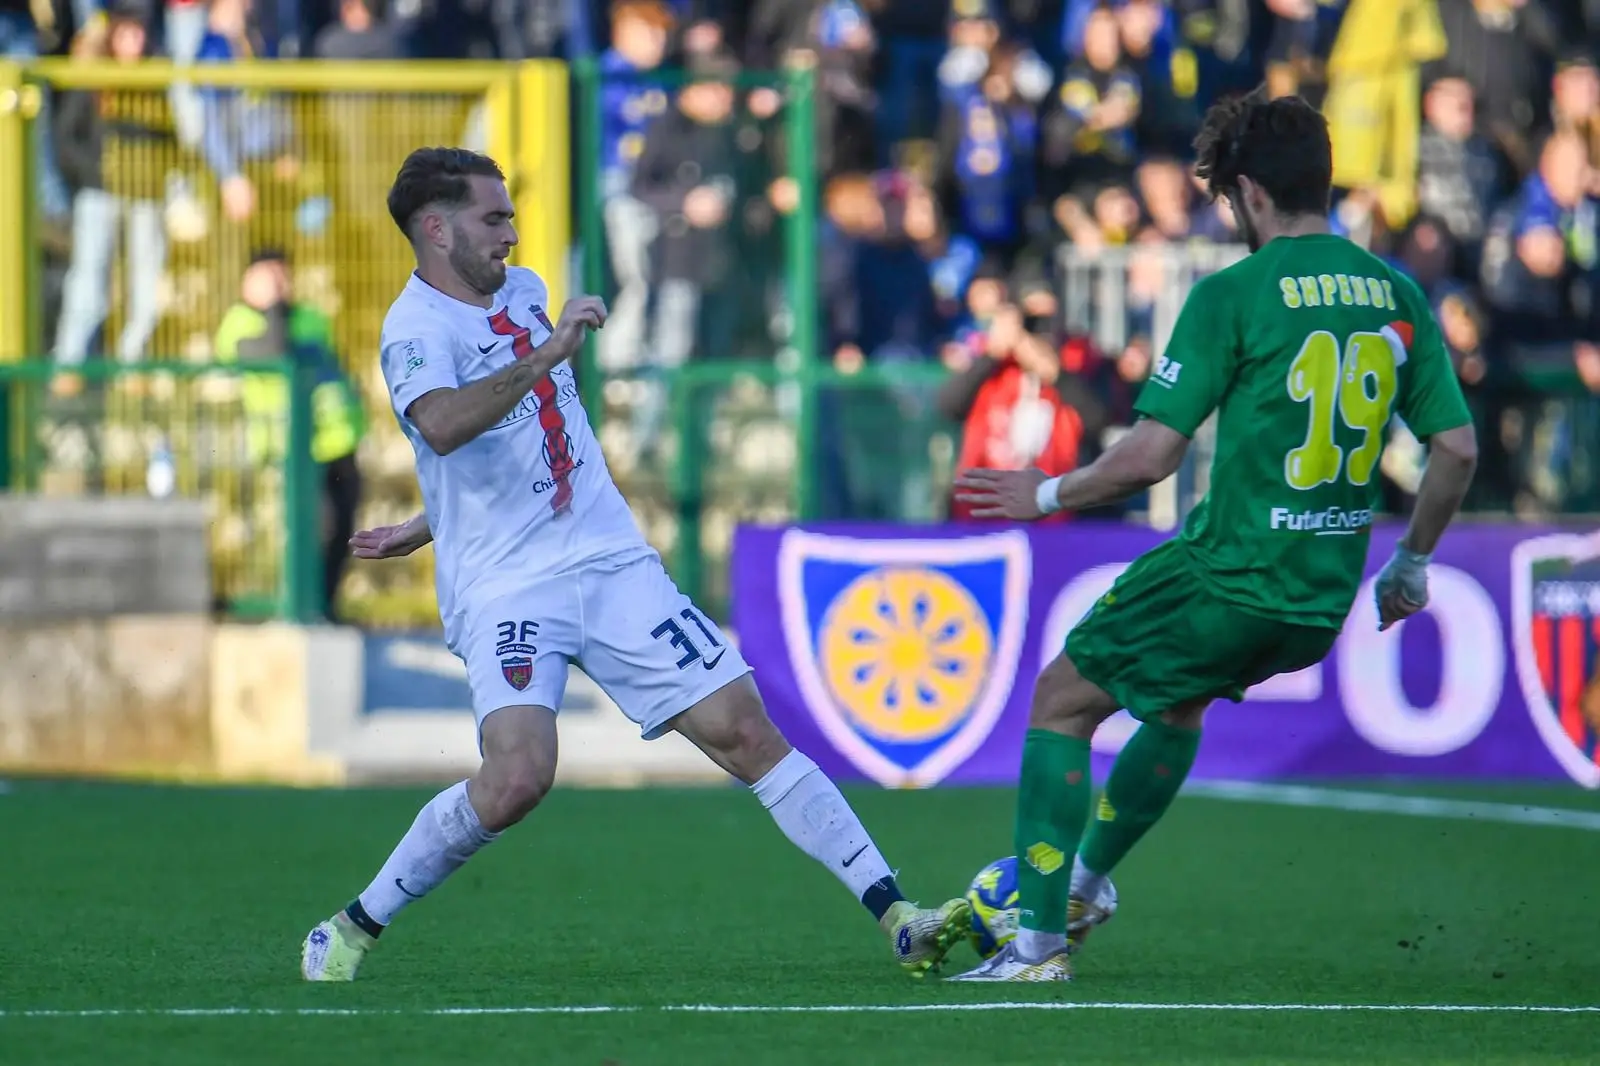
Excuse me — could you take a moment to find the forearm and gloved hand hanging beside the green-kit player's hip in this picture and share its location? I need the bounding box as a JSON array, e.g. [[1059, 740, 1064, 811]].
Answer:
[[1373, 426, 1478, 629]]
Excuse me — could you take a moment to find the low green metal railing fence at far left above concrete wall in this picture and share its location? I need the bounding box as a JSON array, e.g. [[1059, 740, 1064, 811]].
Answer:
[[0, 362, 322, 621]]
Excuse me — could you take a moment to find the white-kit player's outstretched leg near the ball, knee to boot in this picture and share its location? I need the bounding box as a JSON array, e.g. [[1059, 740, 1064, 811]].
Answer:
[[672, 675, 971, 976]]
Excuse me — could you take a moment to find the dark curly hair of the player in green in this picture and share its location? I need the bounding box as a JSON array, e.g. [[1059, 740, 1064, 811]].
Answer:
[[1194, 85, 1333, 214]]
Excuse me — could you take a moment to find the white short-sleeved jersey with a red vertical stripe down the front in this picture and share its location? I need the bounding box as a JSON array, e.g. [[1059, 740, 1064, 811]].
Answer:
[[381, 267, 650, 647]]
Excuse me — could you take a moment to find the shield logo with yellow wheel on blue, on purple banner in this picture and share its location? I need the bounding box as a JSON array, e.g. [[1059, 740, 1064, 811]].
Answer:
[[778, 530, 1030, 787]]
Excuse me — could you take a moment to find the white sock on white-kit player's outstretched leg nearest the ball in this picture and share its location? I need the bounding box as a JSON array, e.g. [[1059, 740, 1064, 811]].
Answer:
[[750, 751, 894, 900]]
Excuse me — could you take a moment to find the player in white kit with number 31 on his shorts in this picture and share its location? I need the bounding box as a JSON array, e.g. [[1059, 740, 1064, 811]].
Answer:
[[301, 149, 971, 981]]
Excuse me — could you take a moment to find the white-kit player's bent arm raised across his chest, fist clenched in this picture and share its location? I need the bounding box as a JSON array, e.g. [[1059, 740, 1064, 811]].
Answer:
[[406, 296, 606, 455]]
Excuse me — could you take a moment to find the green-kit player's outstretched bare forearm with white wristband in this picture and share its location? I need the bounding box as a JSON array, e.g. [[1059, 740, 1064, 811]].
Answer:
[[955, 418, 1189, 522]]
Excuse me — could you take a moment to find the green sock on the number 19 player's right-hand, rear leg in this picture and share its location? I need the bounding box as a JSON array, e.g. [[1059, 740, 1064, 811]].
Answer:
[[1080, 719, 1200, 874]]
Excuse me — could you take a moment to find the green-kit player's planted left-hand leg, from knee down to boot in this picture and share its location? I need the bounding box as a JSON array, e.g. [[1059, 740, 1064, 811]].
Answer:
[[955, 651, 1118, 981]]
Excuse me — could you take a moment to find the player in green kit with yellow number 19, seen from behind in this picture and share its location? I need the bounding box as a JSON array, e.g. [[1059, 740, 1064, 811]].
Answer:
[[954, 90, 1477, 981]]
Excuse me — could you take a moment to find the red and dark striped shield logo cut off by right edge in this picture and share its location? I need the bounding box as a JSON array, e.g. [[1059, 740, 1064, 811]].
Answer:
[[1510, 533, 1600, 789]]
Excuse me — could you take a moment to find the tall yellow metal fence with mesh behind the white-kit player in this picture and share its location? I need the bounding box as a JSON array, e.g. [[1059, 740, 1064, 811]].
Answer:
[[0, 59, 571, 624]]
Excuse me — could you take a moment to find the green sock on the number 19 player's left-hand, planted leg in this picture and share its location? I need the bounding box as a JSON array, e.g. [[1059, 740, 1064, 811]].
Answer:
[[1016, 730, 1094, 935]]
